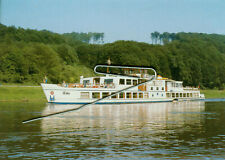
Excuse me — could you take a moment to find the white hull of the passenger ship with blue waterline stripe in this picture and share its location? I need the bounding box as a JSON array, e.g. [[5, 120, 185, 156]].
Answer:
[[41, 84, 204, 104]]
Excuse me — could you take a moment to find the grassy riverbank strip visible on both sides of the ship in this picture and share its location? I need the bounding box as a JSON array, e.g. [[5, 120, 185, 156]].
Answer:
[[0, 85, 225, 103]]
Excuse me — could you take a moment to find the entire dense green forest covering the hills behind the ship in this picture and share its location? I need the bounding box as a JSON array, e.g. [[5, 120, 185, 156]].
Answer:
[[0, 25, 225, 89]]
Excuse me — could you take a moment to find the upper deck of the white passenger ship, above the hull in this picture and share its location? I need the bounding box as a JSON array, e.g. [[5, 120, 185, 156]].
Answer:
[[56, 75, 198, 92]]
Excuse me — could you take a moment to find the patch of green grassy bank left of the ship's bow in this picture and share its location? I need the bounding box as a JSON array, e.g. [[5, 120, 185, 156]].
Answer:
[[0, 86, 46, 102]]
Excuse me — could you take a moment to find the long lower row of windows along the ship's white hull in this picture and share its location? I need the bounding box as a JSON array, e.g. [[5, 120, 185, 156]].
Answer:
[[80, 92, 199, 99]]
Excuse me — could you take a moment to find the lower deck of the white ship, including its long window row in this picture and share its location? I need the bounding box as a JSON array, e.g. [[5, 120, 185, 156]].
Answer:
[[44, 89, 201, 104]]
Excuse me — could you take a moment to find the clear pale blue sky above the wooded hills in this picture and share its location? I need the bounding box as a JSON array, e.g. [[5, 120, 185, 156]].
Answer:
[[1, 0, 225, 43]]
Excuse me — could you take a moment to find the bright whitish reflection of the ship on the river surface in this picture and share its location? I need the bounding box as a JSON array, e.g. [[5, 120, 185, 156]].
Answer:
[[41, 101, 204, 134]]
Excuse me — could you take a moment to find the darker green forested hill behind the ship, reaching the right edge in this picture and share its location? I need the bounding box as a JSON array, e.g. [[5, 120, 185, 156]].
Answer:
[[77, 33, 225, 89]]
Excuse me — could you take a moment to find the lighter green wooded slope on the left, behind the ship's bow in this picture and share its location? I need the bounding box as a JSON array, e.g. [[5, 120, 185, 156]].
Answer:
[[0, 25, 92, 84]]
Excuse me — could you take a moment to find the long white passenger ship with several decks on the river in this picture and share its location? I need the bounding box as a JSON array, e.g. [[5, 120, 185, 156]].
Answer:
[[41, 67, 204, 104]]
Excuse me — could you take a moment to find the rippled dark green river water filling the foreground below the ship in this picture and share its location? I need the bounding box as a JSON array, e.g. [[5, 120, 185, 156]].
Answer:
[[0, 101, 225, 159]]
